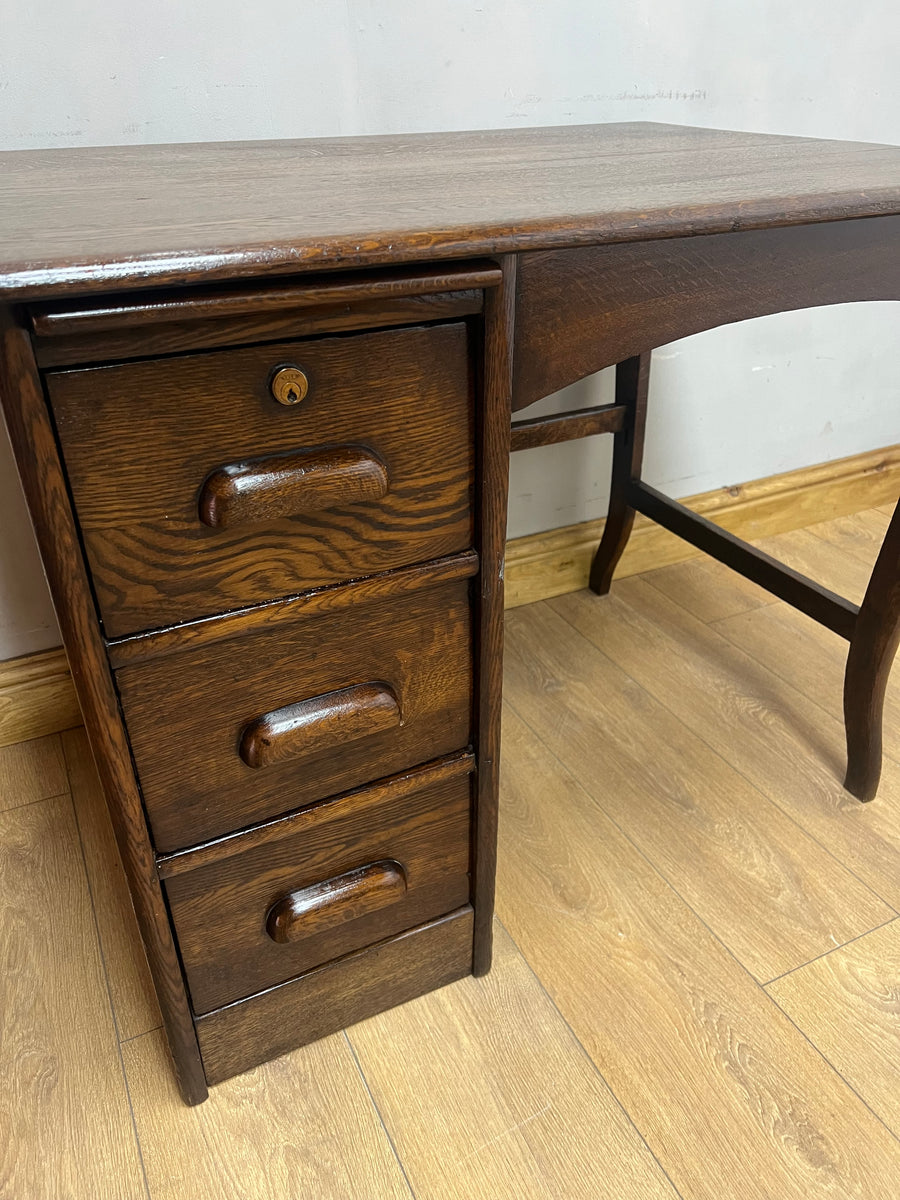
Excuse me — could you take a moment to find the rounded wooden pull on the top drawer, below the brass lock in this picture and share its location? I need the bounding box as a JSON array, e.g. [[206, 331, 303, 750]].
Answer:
[[199, 445, 389, 529]]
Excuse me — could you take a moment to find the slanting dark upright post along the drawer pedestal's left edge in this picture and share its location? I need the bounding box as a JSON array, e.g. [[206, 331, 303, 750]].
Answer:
[[0, 310, 206, 1104]]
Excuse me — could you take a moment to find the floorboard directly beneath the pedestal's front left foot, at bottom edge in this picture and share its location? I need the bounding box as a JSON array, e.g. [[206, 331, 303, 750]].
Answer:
[[122, 1030, 410, 1200]]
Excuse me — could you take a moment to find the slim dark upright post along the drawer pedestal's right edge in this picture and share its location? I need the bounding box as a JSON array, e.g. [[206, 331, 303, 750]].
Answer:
[[473, 256, 516, 974]]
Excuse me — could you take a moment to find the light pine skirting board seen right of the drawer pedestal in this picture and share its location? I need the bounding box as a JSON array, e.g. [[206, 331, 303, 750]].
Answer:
[[505, 445, 900, 608]]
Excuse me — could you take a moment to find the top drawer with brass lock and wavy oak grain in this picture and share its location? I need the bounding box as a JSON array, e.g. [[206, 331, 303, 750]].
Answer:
[[47, 323, 473, 637]]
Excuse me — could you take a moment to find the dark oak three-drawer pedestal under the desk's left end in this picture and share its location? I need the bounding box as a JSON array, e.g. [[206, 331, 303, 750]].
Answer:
[[4, 262, 509, 1103]]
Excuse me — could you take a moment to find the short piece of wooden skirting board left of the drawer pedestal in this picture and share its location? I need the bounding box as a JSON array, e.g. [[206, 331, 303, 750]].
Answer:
[[0, 650, 82, 746]]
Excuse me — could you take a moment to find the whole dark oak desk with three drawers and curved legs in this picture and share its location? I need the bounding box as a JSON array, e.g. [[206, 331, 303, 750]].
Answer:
[[0, 124, 900, 1103]]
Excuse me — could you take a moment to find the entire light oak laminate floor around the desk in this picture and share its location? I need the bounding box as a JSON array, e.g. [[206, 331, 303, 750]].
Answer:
[[0, 509, 900, 1200]]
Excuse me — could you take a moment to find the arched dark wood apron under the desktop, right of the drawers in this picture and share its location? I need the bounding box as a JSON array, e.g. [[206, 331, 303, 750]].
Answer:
[[512, 213, 900, 409]]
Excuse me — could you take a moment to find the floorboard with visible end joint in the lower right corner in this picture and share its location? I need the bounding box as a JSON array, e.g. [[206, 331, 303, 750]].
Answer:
[[768, 920, 900, 1135]]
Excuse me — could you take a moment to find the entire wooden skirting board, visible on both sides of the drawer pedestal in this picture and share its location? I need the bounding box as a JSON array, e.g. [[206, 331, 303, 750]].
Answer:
[[0, 445, 900, 746]]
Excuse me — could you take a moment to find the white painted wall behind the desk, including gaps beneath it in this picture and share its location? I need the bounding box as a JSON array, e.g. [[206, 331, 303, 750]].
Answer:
[[0, 0, 900, 659]]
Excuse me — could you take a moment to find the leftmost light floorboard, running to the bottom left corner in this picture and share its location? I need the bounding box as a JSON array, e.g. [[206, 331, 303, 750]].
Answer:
[[0, 796, 146, 1200]]
